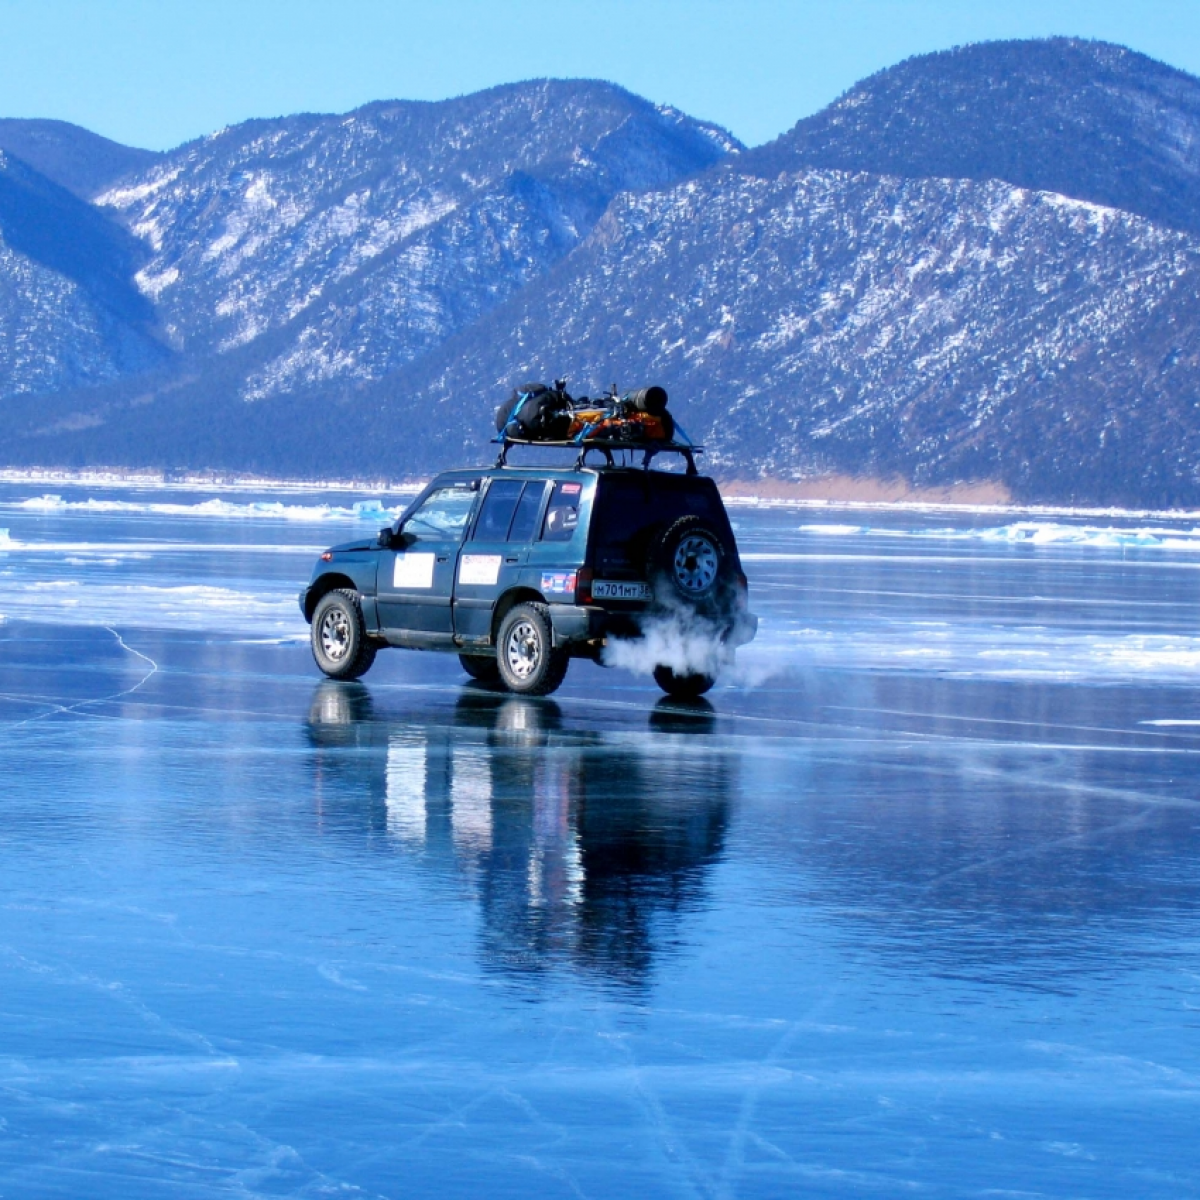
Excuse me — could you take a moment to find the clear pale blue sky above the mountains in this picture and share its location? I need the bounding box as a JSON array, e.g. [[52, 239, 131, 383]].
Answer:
[[7, 0, 1200, 149]]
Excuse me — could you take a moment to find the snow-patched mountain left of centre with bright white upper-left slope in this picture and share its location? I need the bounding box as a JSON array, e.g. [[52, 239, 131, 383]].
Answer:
[[97, 80, 739, 401]]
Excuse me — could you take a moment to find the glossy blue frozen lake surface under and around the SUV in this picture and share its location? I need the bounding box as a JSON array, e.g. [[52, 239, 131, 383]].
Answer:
[[0, 485, 1200, 1198]]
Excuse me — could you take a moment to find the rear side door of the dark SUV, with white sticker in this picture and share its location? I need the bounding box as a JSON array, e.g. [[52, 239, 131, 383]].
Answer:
[[454, 478, 546, 646]]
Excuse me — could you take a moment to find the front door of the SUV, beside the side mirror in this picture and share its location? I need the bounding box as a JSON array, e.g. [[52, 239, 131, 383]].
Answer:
[[376, 479, 479, 646]]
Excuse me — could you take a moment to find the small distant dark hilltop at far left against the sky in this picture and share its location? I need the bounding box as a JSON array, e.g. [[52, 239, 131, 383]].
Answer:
[[0, 118, 162, 200]]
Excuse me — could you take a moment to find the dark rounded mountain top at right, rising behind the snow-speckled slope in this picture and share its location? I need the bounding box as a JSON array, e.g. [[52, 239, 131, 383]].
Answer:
[[738, 37, 1200, 233]]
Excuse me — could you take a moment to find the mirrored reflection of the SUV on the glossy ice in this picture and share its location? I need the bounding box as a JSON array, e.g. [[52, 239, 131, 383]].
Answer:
[[307, 680, 733, 984]]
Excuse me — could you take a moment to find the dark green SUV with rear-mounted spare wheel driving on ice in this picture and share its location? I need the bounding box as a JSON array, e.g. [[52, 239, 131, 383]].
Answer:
[[300, 462, 757, 697]]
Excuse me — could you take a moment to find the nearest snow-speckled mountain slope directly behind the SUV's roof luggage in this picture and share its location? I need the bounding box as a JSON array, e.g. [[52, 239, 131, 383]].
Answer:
[[290, 170, 1200, 505]]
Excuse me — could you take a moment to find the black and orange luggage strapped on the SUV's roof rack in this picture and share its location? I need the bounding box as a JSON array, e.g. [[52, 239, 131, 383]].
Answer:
[[494, 379, 703, 475]]
